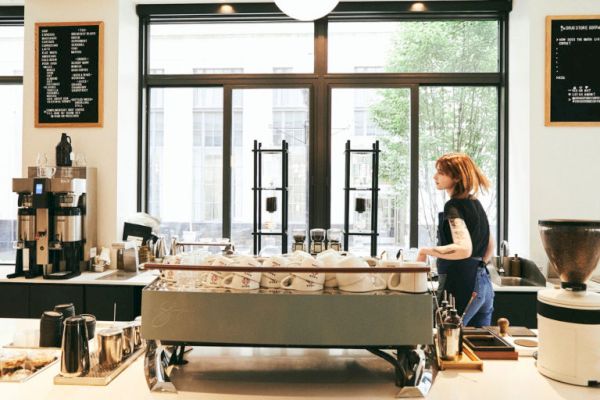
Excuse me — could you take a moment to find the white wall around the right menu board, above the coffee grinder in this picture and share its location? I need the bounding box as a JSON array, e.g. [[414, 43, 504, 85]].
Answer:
[[509, 0, 600, 276]]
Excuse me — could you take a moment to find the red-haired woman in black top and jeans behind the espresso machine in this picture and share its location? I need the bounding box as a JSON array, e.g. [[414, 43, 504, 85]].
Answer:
[[417, 153, 494, 326]]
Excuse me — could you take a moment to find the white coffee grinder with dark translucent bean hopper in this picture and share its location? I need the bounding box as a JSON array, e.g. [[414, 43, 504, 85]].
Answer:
[[537, 220, 600, 386]]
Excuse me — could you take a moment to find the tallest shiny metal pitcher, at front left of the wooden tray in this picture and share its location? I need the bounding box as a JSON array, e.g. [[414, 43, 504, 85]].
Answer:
[[60, 316, 90, 378]]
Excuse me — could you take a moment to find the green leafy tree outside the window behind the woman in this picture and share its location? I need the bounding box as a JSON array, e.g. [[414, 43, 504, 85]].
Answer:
[[370, 21, 498, 245]]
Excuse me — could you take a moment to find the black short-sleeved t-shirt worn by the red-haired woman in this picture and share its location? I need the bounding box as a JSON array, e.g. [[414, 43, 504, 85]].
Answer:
[[438, 199, 490, 273]]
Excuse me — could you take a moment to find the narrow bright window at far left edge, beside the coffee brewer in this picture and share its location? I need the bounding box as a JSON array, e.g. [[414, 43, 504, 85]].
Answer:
[[0, 25, 23, 263]]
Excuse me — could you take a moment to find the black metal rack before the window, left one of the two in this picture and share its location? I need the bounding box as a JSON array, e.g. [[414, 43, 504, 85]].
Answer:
[[252, 140, 288, 255]]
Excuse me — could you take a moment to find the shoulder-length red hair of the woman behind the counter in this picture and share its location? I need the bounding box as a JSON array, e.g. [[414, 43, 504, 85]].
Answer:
[[435, 153, 490, 199]]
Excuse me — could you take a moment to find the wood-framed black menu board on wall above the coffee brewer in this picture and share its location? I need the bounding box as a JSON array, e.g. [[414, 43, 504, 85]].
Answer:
[[35, 22, 104, 127]]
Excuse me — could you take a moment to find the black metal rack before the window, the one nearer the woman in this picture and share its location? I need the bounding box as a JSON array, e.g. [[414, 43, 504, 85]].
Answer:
[[343, 140, 380, 256]]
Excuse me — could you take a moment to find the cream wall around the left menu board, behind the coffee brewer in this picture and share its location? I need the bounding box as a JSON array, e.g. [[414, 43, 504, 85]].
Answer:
[[23, 0, 138, 250]]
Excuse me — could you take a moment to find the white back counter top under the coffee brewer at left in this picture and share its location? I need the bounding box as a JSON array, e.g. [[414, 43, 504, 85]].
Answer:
[[0, 265, 159, 286]]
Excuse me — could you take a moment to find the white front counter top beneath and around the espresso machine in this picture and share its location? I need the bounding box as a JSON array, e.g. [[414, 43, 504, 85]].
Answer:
[[0, 319, 600, 400]]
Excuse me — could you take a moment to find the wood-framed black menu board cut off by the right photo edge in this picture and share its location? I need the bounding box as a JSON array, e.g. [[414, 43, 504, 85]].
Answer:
[[545, 16, 600, 126]]
